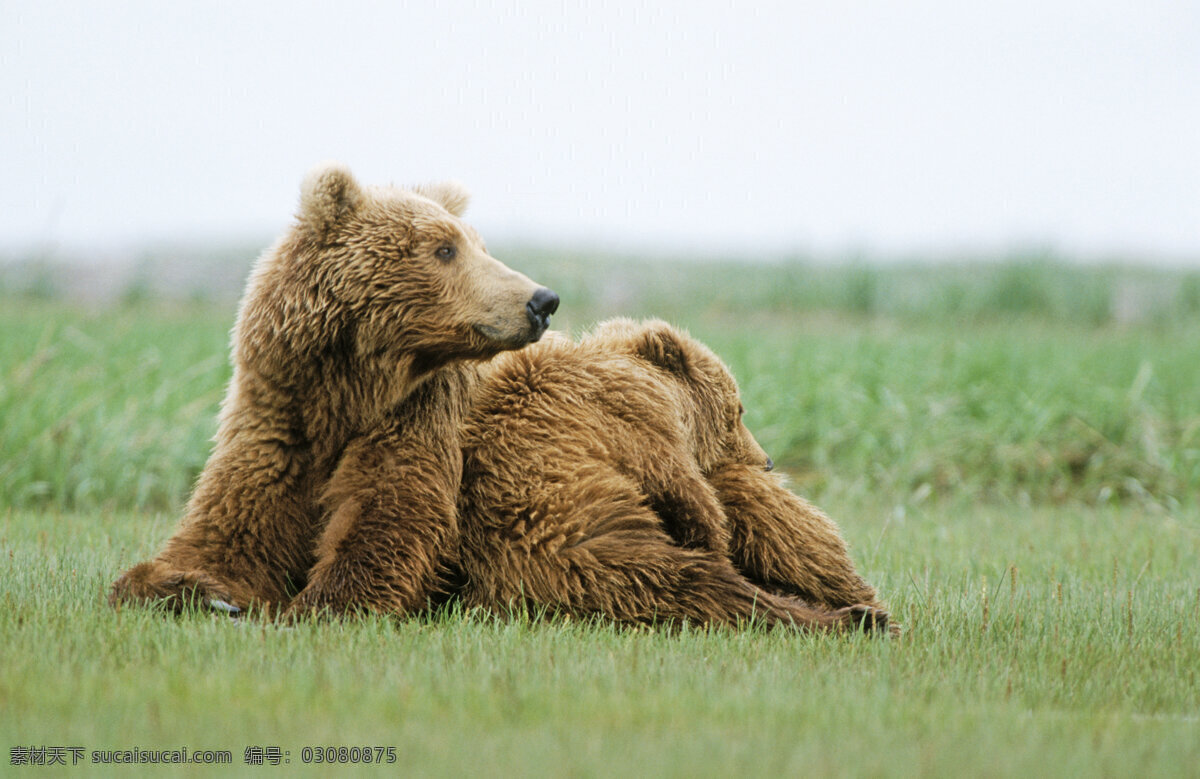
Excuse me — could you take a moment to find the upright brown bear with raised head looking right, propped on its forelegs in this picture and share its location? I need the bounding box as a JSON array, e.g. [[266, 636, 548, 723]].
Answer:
[[110, 166, 558, 612]]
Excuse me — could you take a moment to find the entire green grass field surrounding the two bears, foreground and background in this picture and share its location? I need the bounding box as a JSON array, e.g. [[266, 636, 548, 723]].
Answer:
[[0, 257, 1200, 775]]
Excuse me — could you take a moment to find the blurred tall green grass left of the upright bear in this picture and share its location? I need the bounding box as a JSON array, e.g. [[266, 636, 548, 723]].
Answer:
[[0, 299, 233, 510]]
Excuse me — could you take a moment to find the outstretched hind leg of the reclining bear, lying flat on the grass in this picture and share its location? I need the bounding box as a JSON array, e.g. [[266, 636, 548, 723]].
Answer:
[[463, 482, 888, 631]]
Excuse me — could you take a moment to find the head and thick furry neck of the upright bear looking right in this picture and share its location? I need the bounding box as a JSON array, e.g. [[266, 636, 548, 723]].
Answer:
[[235, 164, 558, 386]]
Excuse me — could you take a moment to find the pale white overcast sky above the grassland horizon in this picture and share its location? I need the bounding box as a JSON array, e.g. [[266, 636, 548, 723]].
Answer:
[[0, 0, 1200, 264]]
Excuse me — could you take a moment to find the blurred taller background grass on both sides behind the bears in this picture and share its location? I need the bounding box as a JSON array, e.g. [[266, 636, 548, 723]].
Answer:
[[0, 248, 1200, 510]]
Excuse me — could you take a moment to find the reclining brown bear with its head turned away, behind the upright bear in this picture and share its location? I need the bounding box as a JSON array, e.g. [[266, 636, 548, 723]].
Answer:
[[458, 319, 889, 631]]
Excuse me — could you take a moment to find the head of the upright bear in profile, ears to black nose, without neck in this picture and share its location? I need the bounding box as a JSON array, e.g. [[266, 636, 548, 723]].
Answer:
[[279, 167, 558, 368]]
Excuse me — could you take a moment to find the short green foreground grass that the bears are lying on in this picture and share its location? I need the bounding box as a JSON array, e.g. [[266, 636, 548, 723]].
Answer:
[[0, 505, 1200, 775]]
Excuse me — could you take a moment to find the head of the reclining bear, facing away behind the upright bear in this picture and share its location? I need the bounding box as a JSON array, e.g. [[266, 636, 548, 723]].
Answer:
[[592, 319, 774, 475]]
